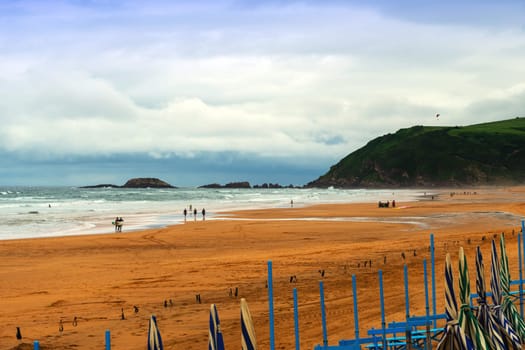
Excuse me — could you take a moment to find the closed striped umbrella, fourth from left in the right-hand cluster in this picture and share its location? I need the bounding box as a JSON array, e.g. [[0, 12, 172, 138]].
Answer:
[[490, 241, 521, 349]]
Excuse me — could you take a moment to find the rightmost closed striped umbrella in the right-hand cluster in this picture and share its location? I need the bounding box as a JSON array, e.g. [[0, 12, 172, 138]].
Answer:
[[499, 235, 525, 343]]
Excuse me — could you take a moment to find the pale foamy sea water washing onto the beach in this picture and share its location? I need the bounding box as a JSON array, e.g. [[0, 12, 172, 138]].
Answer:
[[0, 187, 423, 240]]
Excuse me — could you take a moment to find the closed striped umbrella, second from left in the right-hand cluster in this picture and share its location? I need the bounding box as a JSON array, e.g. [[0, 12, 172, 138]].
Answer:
[[458, 247, 493, 350]]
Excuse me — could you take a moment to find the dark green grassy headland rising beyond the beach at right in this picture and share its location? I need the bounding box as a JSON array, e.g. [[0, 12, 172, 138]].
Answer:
[[307, 118, 525, 187]]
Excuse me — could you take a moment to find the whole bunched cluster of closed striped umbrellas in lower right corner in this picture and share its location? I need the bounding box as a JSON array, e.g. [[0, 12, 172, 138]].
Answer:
[[437, 235, 525, 350]]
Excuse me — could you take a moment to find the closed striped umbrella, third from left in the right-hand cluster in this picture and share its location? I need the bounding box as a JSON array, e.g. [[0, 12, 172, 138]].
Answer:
[[476, 247, 512, 350]]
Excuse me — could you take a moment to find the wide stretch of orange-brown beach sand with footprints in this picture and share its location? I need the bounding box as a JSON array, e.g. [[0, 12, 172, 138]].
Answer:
[[0, 187, 525, 350]]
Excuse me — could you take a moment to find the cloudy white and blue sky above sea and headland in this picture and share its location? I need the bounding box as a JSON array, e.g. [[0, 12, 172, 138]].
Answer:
[[0, 0, 525, 186]]
